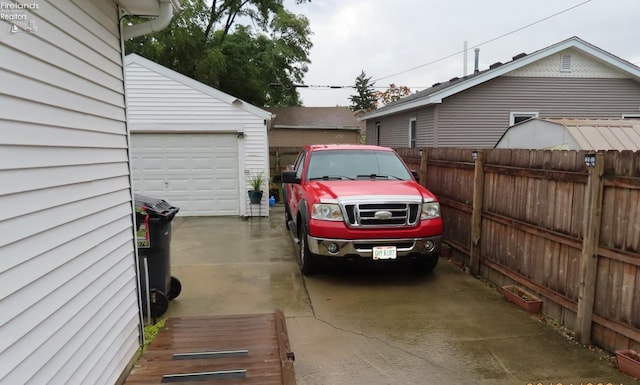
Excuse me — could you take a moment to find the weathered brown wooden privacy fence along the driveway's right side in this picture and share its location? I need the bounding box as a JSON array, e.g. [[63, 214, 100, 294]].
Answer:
[[397, 148, 640, 351]]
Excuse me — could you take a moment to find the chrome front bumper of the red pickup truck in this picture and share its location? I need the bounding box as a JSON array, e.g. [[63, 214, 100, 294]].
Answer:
[[307, 235, 442, 258]]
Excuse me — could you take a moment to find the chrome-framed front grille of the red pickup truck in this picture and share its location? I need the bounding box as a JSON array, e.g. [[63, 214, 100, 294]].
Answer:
[[344, 203, 420, 227]]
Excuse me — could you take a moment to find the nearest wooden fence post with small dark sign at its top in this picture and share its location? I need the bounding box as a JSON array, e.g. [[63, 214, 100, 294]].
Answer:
[[576, 152, 604, 344]]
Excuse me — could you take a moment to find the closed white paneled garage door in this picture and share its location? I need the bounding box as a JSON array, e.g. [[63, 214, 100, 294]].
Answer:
[[131, 134, 240, 215]]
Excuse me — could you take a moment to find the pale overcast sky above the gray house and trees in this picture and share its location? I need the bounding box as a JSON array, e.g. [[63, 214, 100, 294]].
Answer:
[[285, 0, 640, 107]]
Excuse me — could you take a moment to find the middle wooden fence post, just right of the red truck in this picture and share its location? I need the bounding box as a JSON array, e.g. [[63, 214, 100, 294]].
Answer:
[[469, 151, 484, 275]]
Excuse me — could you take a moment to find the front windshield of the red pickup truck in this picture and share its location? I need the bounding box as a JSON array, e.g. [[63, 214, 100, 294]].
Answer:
[[307, 150, 411, 180]]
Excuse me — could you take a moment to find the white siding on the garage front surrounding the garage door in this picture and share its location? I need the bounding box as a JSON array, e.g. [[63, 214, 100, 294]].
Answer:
[[125, 55, 271, 216]]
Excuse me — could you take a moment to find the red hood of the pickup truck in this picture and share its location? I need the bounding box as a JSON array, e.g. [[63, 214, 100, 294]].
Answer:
[[308, 180, 437, 201]]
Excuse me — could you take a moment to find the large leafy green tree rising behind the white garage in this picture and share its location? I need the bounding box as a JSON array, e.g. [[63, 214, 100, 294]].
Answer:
[[125, 0, 312, 106]]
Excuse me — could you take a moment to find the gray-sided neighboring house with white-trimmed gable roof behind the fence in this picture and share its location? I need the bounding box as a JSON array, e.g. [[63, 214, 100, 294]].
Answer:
[[360, 37, 640, 148]]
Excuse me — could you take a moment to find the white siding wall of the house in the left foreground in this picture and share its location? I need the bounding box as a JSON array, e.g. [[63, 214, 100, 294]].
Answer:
[[0, 0, 140, 384]]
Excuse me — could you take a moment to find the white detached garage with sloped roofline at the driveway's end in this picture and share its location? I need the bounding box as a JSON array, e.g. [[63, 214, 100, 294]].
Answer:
[[125, 54, 271, 216]]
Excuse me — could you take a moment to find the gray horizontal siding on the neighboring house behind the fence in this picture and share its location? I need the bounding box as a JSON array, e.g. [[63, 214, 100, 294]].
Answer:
[[372, 76, 640, 147]]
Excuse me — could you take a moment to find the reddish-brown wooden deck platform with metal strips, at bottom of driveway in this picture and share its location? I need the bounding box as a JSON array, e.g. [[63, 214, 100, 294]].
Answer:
[[125, 311, 296, 385]]
